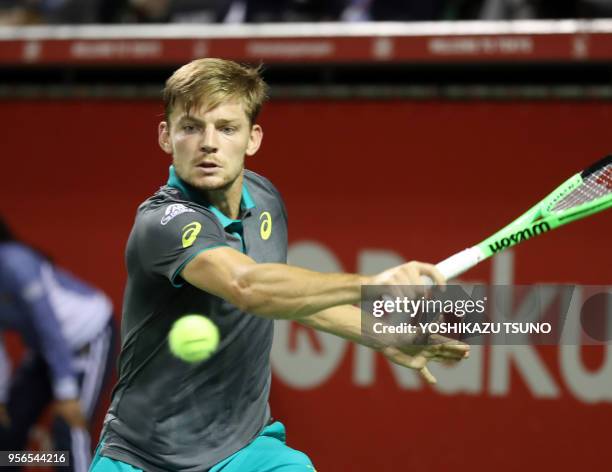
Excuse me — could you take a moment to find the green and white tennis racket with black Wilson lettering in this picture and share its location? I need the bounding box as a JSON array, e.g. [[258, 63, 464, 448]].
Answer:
[[423, 155, 612, 285]]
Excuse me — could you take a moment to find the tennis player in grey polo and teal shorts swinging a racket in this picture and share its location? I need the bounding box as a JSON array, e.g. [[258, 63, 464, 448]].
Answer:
[[91, 59, 467, 472]]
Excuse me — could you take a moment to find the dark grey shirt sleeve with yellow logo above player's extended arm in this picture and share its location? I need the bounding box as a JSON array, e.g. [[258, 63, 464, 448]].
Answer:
[[136, 204, 228, 287]]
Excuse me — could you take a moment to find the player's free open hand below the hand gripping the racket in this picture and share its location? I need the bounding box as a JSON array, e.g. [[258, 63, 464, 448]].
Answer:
[[381, 334, 470, 384]]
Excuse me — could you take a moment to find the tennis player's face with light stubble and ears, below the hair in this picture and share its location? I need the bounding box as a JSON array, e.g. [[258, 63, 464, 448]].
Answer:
[[159, 101, 263, 191]]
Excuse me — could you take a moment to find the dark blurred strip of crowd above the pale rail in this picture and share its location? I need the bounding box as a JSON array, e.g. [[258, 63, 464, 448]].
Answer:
[[0, 0, 612, 25]]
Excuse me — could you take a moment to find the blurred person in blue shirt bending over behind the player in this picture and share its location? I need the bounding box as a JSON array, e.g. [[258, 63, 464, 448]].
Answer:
[[0, 216, 116, 472]]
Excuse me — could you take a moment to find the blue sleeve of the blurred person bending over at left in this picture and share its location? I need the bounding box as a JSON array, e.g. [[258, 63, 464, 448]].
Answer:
[[6, 257, 79, 400]]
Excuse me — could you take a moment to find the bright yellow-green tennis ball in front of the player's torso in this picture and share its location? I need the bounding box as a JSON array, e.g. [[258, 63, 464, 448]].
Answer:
[[168, 315, 219, 363]]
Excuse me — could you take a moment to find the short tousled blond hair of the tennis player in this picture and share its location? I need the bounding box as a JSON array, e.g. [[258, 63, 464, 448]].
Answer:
[[163, 58, 268, 124]]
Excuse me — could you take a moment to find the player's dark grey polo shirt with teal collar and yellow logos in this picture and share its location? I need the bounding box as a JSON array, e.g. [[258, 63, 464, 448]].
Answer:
[[102, 167, 287, 472]]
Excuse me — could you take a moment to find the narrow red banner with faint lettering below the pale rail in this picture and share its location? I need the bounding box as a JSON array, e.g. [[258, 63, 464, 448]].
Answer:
[[0, 26, 612, 65]]
